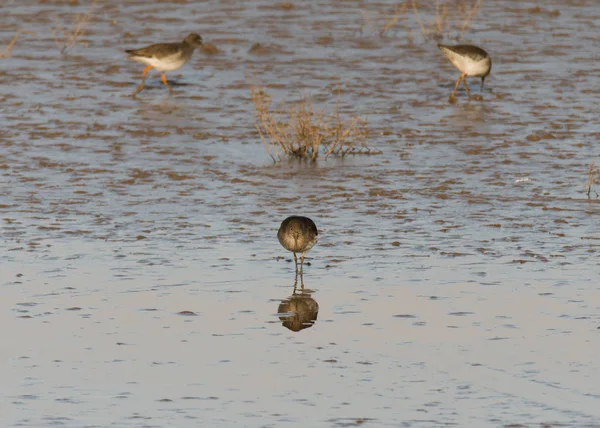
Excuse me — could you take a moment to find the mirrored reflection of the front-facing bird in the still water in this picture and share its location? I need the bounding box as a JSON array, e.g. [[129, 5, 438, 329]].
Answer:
[[277, 273, 319, 332]]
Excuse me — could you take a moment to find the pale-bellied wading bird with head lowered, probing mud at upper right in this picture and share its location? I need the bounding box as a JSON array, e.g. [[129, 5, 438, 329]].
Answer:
[[438, 44, 492, 102]]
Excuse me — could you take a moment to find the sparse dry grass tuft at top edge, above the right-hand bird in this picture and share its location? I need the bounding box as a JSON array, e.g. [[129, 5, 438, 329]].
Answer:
[[412, 0, 483, 40]]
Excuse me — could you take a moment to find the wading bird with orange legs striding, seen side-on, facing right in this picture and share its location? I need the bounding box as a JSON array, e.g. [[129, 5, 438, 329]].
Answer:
[[125, 33, 202, 96]]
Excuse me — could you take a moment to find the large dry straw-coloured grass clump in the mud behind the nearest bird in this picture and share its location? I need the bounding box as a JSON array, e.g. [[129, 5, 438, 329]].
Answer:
[[250, 85, 381, 162]]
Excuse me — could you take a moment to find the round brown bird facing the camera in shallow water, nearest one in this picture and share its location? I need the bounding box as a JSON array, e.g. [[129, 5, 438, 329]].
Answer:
[[277, 216, 319, 272]]
